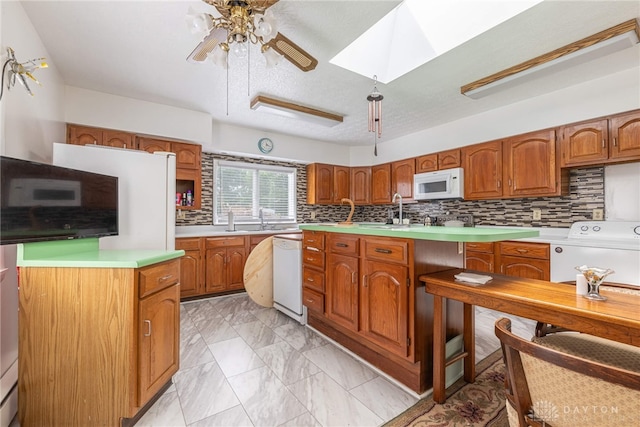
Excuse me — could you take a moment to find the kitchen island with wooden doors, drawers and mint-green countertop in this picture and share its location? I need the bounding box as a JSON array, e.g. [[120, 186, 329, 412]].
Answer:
[[299, 224, 538, 394]]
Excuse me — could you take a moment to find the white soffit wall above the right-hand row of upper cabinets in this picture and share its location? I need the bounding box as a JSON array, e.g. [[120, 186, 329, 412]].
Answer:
[[350, 68, 640, 166]]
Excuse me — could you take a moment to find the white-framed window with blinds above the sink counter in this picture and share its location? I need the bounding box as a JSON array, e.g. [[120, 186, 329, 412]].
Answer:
[[213, 160, 296, 224]]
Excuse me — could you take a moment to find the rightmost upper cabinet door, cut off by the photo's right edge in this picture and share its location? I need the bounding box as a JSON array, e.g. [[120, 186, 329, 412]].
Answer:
[[609, 111, 640, 160]]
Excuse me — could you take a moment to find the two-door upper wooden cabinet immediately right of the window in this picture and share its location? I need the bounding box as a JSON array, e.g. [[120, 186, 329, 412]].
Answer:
[[307, 163, 351, 205]]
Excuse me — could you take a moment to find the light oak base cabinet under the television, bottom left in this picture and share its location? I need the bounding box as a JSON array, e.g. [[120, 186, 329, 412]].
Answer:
[[18, 259, 180, 426]]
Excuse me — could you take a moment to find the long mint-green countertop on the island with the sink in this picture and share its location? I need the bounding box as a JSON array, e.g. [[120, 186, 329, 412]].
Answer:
[[299, 224, 539, 242]]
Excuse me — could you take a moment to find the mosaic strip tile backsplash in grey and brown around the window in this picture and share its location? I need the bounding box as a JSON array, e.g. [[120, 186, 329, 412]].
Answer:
[[176, 153, 604, 227]]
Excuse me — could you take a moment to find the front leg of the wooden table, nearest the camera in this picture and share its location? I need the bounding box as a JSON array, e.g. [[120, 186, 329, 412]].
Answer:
[[433, 295, 447, 403]]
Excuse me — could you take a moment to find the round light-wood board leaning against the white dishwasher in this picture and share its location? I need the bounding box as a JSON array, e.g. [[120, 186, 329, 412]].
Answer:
[[243, 237, 273, 307]]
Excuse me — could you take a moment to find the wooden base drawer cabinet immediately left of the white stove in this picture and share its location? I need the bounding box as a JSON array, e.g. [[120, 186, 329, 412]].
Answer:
[[496, 241, 551, 280]]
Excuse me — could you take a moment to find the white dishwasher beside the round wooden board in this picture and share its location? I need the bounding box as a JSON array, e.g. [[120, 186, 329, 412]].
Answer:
[[273, 234, 307, 325]]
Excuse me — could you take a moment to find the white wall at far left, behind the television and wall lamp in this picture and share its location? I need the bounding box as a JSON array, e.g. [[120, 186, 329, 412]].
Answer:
[[0, 1, 65, 427]]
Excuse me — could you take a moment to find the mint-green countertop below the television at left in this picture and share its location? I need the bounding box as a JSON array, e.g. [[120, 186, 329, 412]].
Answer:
[[17, 238, 184, 268]]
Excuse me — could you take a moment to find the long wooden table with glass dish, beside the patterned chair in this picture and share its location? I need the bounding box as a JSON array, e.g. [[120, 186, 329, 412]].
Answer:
[[419, 269, 640, 403]]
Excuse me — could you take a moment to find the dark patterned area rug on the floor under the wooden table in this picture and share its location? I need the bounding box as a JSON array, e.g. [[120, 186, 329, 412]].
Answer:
[[385, 350, 509, 427]]
